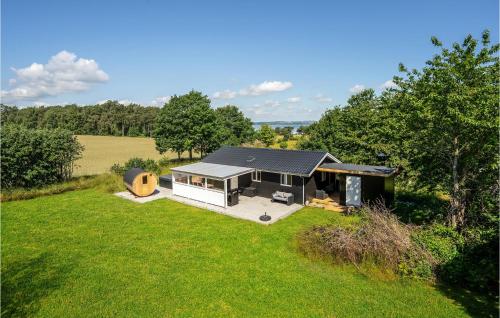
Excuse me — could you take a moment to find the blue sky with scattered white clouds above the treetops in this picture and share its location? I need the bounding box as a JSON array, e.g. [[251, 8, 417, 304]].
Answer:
[[1, 0, 499, 121]]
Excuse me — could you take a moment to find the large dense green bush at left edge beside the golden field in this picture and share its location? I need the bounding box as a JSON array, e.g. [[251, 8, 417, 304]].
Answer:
[[1, 125, 83, 188]]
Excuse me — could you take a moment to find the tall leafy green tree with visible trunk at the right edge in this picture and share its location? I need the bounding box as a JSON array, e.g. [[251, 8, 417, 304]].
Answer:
[[394, 31, 499, 228]]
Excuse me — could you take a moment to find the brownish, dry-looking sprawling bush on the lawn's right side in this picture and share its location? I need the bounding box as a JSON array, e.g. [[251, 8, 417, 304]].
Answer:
[[299, 205, 435, 278]]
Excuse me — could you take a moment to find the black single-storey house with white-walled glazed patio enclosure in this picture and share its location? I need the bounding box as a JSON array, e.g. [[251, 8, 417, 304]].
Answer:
[[166, 147, 395, 208]]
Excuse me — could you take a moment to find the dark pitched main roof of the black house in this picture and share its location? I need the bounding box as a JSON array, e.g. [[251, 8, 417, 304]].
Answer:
[[202, 147, 336, 176]]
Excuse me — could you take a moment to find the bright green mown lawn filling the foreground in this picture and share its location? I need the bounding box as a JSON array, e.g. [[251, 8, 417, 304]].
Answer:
[[2, 189, 488, 317]]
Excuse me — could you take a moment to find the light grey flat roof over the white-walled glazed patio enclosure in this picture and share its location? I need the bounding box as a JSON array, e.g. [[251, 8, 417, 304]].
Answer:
[[170, 162, 255, 180]]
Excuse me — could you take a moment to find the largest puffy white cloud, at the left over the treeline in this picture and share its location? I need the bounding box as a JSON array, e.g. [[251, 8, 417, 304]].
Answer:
[[1, 51, 109, 101]]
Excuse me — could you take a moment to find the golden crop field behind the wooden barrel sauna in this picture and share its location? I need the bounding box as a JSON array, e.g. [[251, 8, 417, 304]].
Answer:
[[75, 135, 177, 176]]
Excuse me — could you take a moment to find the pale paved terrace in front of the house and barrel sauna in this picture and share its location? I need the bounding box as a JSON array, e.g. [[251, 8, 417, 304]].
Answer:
[[115, 187, 302, 224]]
